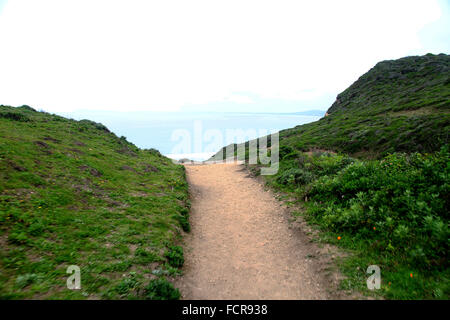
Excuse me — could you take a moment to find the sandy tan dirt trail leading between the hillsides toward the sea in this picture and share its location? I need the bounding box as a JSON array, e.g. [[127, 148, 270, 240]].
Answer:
[[176, 164, 342, 299]]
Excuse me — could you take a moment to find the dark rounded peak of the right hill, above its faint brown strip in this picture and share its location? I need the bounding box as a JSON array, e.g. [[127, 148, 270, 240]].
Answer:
[[327, 54, 450, 114]]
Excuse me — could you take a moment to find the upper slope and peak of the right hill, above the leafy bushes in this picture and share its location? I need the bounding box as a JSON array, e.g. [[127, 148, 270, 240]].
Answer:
[[211, 54, 450, 160]]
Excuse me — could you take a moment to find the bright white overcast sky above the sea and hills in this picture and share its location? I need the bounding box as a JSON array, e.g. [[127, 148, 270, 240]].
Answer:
[[0, 0, 450, 112]]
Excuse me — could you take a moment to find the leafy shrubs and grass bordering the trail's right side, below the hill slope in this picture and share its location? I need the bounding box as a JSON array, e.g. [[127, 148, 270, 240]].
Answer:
[[267, 146, 450, 299]]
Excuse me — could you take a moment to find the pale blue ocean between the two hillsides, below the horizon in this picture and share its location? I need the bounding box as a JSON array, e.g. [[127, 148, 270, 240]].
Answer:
[[58, 110, 321, 161]]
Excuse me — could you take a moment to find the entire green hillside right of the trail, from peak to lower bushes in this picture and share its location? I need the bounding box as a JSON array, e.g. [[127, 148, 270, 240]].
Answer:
[[213, 55, 450, 299]]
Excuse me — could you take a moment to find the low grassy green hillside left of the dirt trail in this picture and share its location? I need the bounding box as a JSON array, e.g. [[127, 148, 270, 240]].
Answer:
[[0, 106, 189, 299]]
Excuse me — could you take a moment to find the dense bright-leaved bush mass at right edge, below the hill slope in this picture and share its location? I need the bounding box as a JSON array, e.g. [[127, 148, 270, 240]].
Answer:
[[308, 148, 450, 270]]
